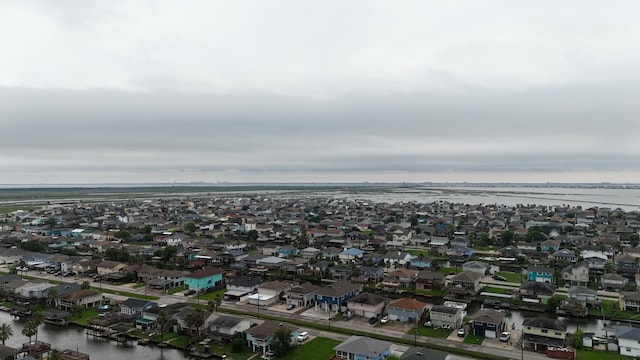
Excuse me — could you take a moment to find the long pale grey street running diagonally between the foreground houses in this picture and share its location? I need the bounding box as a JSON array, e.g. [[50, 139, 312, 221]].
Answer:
[[17, 268, 549, 360]]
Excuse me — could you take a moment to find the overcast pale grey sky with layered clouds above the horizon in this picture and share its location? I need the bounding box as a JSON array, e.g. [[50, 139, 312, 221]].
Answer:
[[0, 0, 640, 184]]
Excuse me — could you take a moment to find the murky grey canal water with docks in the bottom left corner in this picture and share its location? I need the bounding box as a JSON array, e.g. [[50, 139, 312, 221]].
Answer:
[[0, 312, 189, 360]]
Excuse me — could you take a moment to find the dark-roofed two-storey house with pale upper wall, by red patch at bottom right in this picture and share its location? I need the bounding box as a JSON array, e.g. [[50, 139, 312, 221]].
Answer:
[[522, 318, 567, 351]]
